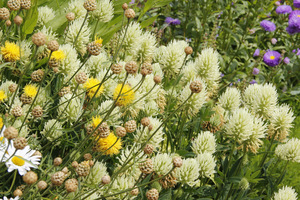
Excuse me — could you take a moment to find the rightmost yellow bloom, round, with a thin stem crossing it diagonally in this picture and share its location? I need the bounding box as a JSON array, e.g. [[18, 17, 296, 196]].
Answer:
[[113, 84, 135, 106]]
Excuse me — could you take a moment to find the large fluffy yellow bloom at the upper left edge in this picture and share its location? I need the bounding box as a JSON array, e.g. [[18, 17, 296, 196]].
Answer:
[[1, 41, 20, 62]]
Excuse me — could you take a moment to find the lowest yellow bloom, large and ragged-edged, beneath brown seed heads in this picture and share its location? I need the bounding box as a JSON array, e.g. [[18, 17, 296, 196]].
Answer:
[[94, 132, 122, 156]]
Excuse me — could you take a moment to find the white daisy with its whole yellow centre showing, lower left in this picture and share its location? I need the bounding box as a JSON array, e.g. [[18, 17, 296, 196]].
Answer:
[[5, 142, 41, 176]]
